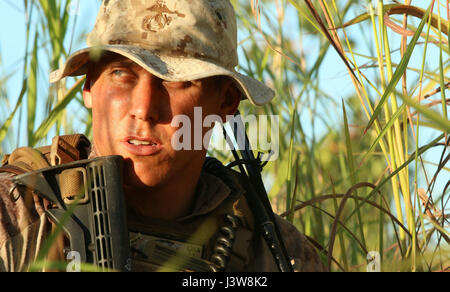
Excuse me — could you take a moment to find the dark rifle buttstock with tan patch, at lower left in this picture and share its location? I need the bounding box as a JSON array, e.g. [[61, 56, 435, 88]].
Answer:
[[13, 156, 131, 271]]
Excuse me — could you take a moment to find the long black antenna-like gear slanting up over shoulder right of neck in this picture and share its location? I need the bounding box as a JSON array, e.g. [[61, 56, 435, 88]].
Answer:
[[223, 111, 293, 272]]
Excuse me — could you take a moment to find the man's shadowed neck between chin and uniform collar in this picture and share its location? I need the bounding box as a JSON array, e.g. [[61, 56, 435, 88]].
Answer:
[[124, 163, 201, 221]]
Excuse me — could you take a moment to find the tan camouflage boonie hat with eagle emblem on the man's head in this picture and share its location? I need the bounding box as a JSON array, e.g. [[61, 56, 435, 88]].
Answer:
[[50, 0, 274, 105]]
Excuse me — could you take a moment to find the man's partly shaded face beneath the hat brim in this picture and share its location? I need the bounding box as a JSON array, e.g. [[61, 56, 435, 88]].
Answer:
[[83, 55, 239, 188]]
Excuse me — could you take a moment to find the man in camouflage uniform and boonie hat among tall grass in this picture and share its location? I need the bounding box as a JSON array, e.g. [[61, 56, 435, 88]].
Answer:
[[0, 0, 324, 272]]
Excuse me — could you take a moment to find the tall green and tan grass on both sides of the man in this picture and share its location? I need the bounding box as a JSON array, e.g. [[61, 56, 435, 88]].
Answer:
[[0, 0, 450, 271]]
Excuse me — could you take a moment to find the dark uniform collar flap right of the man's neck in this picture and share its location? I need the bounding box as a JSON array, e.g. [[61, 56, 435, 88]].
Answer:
[[89, 147, 236, 223]]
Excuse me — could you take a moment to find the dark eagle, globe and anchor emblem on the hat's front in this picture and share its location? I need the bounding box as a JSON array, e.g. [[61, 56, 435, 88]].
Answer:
[[142, 0, 185, 32]]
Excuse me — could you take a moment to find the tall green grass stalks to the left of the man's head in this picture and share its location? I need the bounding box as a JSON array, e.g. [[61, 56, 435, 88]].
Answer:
[[0, 0, 92, 151]]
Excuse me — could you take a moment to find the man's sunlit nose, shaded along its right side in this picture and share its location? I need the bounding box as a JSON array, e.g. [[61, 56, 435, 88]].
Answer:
[[130, 73, 163, 122]]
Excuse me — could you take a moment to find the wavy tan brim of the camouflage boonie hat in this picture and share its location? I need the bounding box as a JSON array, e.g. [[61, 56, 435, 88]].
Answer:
[[50, 45, 275, 105]]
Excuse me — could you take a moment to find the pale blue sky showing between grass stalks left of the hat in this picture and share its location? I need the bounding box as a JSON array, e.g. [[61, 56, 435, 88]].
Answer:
[[0, 0, 101, 148]]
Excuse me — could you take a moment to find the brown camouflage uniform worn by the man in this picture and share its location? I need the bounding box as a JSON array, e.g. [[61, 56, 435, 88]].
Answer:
[[0, 149, 325, 272]]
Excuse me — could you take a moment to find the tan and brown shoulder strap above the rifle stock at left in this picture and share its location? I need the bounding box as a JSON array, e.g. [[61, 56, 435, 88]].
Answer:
[[0, 134, 90, 175]]
